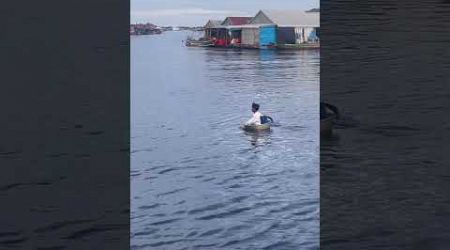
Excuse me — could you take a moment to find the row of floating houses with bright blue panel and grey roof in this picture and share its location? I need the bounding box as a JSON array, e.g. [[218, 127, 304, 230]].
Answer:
[[192, 10, 320, 49]]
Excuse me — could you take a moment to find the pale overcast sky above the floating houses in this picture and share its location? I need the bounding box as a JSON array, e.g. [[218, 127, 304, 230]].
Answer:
[[130, 0, 320, 26]]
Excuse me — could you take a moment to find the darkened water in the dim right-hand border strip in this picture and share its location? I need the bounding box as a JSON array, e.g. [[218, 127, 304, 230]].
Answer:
[[320, 0, 450, 249]]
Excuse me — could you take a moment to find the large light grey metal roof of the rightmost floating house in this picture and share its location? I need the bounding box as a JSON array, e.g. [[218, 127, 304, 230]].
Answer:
[[253, 10, 320, 27]]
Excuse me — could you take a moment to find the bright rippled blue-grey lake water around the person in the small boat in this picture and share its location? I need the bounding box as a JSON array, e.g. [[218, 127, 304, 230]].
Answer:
[[131, 32, 320, 249]]
